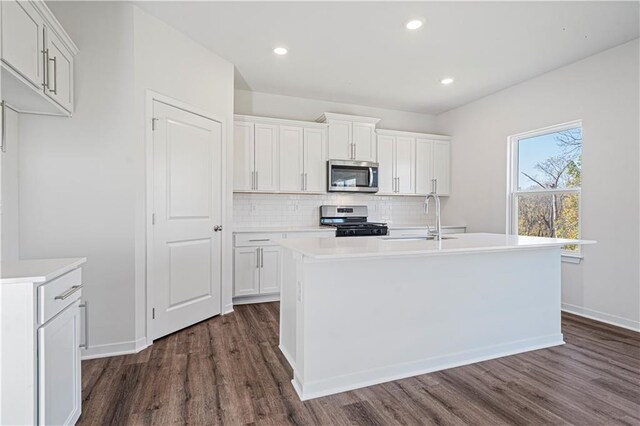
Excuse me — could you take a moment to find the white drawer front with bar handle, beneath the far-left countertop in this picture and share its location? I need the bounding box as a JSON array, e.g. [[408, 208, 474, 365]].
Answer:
[[38, 268, 82, 324]]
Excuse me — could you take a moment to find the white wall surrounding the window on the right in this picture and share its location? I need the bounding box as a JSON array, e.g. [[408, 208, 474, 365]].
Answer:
[[437, 40, 640, 330]]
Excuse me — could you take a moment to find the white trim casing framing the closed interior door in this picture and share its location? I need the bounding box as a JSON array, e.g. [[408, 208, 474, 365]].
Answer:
[[144, 89, 233, 345]]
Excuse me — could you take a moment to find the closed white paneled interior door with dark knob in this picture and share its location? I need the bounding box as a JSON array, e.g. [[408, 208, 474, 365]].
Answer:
[[149, 102, 223, 339]]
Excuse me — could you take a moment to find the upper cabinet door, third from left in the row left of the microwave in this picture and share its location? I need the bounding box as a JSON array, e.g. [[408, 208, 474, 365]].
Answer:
[[280, 126, 304, 192]]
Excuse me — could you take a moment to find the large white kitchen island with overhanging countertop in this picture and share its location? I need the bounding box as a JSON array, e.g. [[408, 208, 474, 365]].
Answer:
[[279, 233, 591, 400]]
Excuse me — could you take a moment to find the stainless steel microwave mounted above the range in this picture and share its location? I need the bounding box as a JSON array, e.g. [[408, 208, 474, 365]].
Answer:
[[327, 160, 378, 192]]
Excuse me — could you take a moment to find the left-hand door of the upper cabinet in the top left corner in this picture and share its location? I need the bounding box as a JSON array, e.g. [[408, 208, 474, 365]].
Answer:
[[0, 0, 44, 90]]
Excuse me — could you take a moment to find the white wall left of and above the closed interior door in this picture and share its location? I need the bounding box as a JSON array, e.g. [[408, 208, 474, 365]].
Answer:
[[20, 2, 233, 355]]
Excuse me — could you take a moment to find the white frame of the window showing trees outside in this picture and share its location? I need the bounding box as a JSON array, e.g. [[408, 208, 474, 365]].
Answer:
[[506, 120, 584, 263]]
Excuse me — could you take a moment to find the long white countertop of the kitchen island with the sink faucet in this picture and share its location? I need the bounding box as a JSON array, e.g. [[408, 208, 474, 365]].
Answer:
[[276, 233, 595, 259]]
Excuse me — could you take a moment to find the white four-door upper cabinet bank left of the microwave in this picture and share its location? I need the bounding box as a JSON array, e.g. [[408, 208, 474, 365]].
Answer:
[[233, 115, 327, 193]]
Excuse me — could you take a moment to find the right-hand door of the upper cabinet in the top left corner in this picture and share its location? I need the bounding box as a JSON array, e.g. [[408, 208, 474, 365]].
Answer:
[[45, 26, 73, 112]]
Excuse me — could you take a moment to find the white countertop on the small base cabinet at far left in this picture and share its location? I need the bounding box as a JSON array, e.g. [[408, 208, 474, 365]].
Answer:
[[0, 257, 87, 284]]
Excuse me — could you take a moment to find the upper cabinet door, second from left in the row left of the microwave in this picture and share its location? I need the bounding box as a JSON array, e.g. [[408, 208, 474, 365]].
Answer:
[[254, 123, 278, 192]]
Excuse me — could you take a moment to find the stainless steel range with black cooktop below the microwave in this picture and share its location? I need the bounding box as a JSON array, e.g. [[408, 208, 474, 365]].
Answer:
[[320, 206, 388, 237]]
